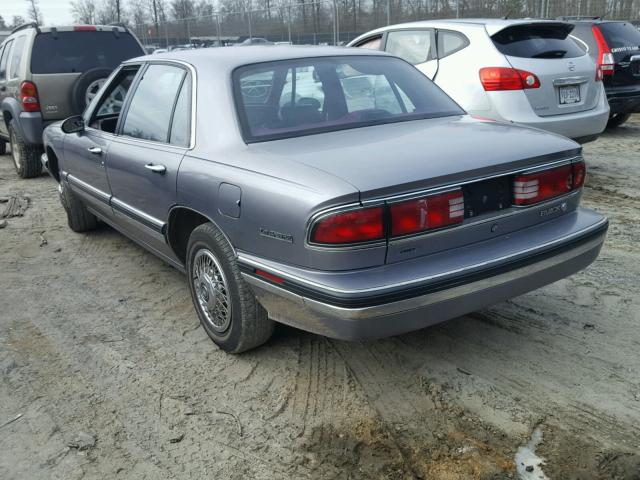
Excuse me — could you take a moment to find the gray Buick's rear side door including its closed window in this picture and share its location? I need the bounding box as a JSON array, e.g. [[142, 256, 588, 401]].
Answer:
[[107, 63, 192, 260]]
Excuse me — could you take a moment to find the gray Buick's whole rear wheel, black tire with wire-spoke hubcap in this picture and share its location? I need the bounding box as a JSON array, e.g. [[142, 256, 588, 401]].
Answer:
[[187, 223, 274, 353]]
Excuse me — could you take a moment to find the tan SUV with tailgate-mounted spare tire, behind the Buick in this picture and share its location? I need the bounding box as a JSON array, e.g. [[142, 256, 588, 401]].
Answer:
[[0, 24, 145, 178]]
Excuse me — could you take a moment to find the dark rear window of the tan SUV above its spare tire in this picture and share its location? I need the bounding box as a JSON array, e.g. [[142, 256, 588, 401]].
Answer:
[[31, 32, 145, 74]]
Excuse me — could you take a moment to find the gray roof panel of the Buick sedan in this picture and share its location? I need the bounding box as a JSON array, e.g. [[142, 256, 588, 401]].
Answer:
[[124, 45, 390, 70]]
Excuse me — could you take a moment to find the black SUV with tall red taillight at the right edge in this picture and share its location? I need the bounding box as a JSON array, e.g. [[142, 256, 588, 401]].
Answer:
[[565, 18, 640, 127]]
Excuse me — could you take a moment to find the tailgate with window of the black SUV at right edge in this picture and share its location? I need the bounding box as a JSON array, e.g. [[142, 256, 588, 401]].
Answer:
[[598, 22, 640, 87]]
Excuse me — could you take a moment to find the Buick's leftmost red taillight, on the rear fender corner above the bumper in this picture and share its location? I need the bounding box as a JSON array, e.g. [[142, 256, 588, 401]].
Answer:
[[311, 207, 385, 245]]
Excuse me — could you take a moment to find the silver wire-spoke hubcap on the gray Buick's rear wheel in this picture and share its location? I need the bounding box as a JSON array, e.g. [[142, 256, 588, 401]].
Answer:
[[191, 249, 231, 333]]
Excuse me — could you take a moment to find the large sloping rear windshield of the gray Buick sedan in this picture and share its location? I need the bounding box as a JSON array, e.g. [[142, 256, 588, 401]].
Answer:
[[233, 56, 464, 142]]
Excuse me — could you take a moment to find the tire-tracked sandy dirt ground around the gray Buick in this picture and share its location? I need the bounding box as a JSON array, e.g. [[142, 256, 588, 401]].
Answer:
[[0, 116, 640, 480]]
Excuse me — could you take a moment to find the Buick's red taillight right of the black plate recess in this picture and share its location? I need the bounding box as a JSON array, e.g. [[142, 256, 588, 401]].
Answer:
[[513, 161, 586, 206]]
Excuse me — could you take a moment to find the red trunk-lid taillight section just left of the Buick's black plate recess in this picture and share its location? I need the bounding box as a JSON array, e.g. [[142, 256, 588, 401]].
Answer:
[[391, 189, 464, 237]]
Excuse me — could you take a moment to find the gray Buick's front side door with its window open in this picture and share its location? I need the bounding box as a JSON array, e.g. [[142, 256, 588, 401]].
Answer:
[[64, 67, 138, 216]]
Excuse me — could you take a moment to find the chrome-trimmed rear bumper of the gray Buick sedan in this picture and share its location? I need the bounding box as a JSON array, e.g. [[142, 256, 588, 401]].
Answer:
[[239, 209, 608, 340]]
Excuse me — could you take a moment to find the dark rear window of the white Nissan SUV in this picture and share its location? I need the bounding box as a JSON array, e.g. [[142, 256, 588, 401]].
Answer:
[[491, 24, 585, 58]]
